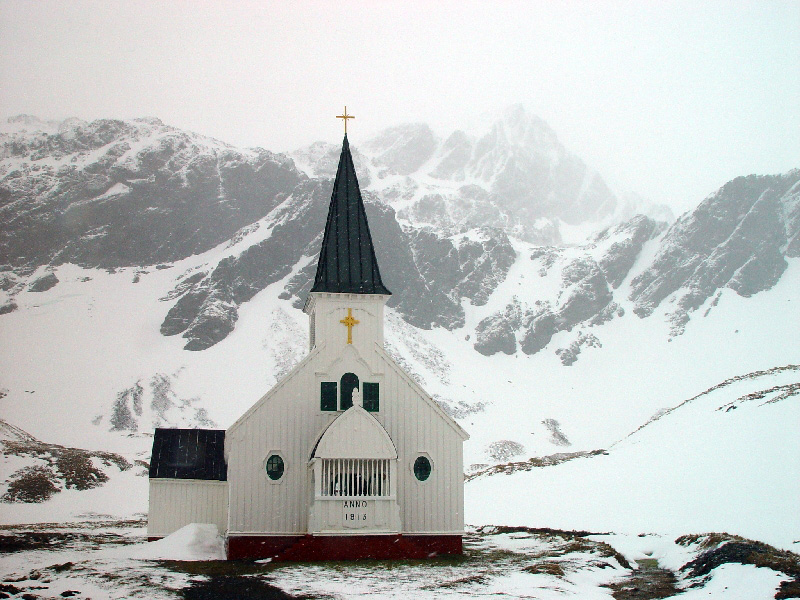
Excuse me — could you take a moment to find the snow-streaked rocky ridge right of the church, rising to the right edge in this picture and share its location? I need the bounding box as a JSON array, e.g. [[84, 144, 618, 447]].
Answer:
[[475, 170, 800, 356]]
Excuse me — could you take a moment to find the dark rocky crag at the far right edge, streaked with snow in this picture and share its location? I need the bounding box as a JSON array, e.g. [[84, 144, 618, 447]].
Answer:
[[630, 169, 800, 334]]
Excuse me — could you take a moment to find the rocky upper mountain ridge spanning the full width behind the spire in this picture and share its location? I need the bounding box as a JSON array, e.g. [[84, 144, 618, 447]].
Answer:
[[0, 113, 800, 364]]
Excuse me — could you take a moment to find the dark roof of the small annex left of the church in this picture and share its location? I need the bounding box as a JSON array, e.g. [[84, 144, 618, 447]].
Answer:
[[150, 429, 228, 481]]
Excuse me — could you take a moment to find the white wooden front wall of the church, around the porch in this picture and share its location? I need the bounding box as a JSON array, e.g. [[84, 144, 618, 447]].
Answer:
[[225, 294, 466, 534]]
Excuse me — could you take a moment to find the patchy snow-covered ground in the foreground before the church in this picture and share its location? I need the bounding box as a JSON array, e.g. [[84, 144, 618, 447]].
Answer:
[[0, 523, 788, 600]]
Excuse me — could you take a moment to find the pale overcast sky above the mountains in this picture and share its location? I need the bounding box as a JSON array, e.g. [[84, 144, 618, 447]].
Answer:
[[0, 0, 800, 211]]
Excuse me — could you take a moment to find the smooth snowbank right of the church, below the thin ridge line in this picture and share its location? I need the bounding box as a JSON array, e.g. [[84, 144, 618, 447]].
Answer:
[[465, 368, 800, 551]]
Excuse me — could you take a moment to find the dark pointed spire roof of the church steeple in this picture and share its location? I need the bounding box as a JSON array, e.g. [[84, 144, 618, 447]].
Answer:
[[311, 134, 391, 294]]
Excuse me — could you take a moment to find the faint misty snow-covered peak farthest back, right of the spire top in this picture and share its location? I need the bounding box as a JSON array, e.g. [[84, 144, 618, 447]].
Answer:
[[291, 106, 672, 244]]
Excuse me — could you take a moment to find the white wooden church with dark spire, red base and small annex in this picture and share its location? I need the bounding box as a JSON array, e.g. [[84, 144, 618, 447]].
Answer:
[[147, 123, 468, 560]]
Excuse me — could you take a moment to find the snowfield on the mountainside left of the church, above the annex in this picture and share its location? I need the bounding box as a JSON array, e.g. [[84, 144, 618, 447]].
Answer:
[[0, 260, 306, 452]]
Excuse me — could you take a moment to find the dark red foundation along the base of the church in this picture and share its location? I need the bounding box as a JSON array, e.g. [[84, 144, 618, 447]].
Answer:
[[227, 535, 462, 562]]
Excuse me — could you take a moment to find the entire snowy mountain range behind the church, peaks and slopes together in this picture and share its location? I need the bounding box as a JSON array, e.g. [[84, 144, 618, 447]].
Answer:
[[0, 108, 800, 543]]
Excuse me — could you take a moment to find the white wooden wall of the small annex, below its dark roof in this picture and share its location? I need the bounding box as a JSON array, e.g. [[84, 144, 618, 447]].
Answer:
[[147, 479, 228, 537]]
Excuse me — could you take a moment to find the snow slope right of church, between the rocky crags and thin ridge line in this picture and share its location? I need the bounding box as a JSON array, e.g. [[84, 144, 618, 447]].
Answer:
[[418, 261, 800, 474]]
